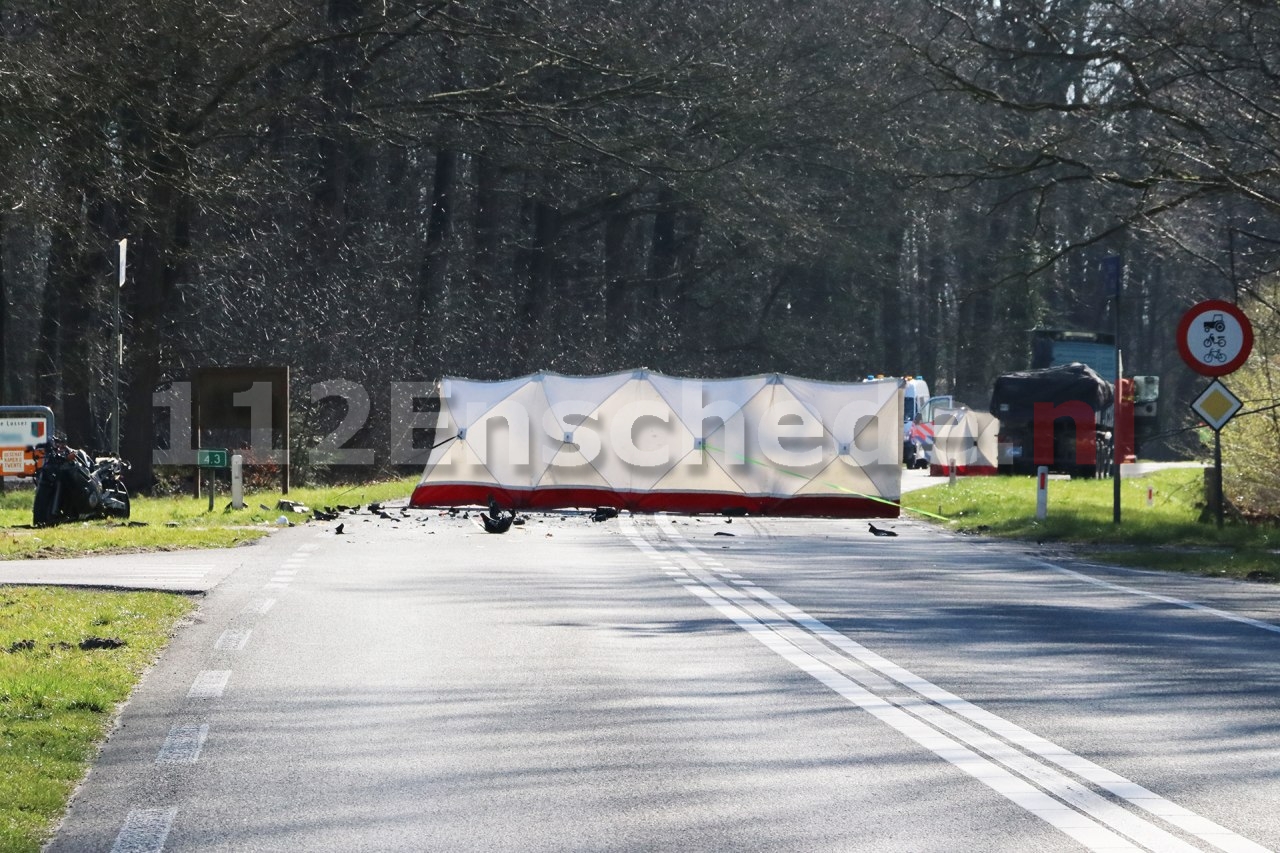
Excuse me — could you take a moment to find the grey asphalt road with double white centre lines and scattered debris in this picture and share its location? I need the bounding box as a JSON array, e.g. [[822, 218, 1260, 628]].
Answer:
[[27, 512, 1280, 852]]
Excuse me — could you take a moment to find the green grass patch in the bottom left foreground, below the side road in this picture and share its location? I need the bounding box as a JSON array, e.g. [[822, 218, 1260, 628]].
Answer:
[[0, 587, 192, 853]]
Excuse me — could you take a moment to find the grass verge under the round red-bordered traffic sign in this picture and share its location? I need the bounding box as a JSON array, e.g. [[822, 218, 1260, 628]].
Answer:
[[902, 469, 1280, 581]]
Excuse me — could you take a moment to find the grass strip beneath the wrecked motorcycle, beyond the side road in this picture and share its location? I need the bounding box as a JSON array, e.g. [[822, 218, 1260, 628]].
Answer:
[[0, 476, 417, 560]]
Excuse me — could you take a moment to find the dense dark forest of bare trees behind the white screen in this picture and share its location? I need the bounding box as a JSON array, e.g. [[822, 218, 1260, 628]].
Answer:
[[0, 0, 1280, 483]]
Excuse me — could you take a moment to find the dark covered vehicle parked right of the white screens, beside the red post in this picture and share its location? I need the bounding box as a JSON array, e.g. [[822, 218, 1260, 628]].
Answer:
[[991, 362, 1115, 476]]
